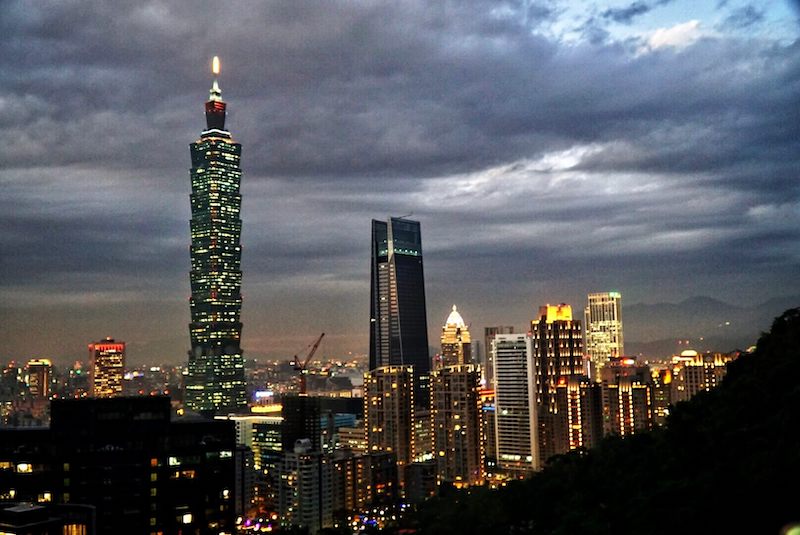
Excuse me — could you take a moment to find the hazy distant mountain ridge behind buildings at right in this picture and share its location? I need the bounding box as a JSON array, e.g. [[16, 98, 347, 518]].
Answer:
[[622, 295, 800, 358]]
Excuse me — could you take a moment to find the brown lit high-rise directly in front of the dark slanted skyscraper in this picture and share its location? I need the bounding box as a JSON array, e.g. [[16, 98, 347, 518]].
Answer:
[[364, 366, 416, 485]]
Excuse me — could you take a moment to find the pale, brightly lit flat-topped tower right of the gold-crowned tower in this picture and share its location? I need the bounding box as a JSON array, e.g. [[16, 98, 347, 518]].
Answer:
[[584, 292, 625, 381]]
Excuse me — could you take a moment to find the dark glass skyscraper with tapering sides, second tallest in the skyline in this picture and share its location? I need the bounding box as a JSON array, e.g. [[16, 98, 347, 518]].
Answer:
[[369, 217, 431, 406]]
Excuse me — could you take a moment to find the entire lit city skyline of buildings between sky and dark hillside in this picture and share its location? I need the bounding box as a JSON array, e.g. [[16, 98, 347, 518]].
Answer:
[[0, 58, 733, 535]]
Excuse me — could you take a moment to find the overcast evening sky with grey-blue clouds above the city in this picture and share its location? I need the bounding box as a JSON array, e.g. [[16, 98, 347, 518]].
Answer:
[[0, 0, 800, 363]]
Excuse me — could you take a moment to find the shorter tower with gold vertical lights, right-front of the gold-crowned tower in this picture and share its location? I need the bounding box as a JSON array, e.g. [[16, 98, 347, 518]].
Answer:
[[556, 375, 603, 452]]
